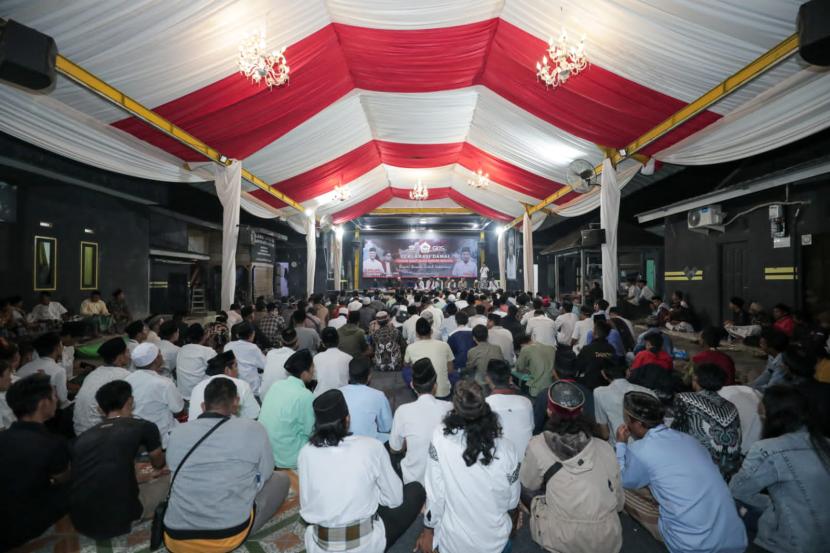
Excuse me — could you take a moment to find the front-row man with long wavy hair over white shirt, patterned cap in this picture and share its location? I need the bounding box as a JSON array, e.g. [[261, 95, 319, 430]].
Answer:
[[415, 380, 521, 553]]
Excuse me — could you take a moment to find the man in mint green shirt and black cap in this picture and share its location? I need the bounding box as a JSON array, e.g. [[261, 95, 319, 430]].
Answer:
[[259, 349, 314, 469]]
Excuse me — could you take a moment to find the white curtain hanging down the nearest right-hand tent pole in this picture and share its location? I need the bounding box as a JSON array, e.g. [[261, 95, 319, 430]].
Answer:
[[599, 159, 620, 307]]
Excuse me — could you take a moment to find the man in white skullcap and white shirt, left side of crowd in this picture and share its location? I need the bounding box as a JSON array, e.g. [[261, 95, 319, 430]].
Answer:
[[125, 342, 184, 449]]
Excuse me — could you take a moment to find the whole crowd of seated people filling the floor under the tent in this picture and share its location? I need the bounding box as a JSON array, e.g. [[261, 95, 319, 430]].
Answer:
[[0, 283, 830, 553]]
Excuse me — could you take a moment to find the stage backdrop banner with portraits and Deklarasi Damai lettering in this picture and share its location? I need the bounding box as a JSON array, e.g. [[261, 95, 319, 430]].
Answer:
[[361, 235, 478, 279]]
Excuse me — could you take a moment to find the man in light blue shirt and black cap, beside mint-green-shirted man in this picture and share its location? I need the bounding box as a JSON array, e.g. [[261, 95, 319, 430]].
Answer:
[[340, 356, 392, 442]]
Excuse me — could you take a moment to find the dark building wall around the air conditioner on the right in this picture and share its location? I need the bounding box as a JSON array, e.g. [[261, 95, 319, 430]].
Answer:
[[665, 182, 830, 325]]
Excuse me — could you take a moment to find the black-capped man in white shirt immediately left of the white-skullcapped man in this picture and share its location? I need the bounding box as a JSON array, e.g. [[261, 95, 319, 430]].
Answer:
[[72, 337, 132, 436]]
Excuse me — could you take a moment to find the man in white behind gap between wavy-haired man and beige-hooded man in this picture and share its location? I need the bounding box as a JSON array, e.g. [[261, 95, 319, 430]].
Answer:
[[487, 360, 534, 459]]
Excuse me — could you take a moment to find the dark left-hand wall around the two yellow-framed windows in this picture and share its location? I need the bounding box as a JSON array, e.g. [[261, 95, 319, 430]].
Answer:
[[5, 182, 150, 315]]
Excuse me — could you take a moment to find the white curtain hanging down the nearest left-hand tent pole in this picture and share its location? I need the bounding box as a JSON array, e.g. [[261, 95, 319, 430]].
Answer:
[[214, 160, 242, 310]]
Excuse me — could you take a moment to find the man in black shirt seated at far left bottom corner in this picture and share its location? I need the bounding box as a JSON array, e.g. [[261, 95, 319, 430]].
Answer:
[[0, 374, 70, 551]]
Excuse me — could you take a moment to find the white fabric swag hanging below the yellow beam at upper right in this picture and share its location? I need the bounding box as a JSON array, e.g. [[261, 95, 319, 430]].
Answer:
[[656, 67, 830, 165]]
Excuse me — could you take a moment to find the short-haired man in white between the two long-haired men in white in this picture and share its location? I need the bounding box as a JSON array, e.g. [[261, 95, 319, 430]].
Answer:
[[389, 357, 452, 485]]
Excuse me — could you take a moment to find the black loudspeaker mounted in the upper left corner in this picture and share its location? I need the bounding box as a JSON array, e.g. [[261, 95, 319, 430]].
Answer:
[[0, 19, 58, 90]]
